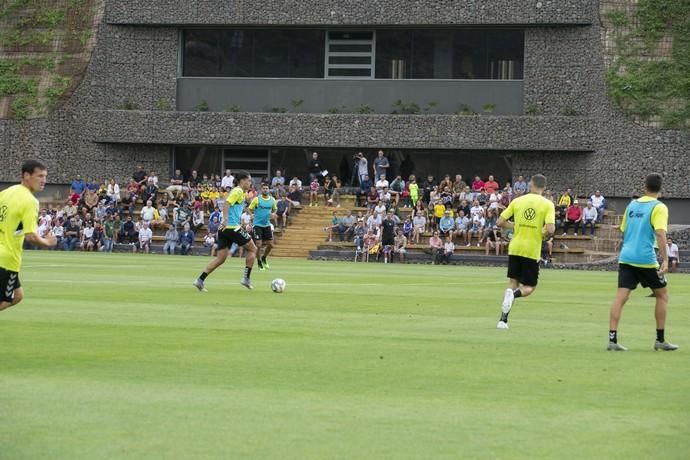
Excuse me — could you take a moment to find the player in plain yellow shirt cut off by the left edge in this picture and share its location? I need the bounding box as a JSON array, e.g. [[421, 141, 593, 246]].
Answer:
[[0, 160, 57, 311]]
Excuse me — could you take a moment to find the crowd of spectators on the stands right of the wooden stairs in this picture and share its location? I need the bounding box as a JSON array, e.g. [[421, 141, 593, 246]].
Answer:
[[318, 151, 606, 264]]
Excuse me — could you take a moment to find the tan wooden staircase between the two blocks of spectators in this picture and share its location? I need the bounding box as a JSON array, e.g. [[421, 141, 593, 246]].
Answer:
[[271, 206, 334, 259]]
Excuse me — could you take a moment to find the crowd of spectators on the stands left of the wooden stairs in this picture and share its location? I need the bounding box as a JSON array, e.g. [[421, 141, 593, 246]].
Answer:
[[30, 166, 298, 255]]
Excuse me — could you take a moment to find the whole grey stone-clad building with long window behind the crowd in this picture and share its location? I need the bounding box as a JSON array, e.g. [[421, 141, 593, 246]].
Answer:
[[0, 0, 690, 221]]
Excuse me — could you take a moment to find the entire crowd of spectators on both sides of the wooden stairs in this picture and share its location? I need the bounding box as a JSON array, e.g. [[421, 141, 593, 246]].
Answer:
[[30, 151, 606, 264]]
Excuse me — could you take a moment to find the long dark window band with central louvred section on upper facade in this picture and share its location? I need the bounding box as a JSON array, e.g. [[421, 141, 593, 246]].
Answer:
[[182, 28, 524, 80]]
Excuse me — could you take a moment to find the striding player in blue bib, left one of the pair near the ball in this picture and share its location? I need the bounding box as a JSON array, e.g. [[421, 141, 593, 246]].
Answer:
[[194, 171, 256, 291]]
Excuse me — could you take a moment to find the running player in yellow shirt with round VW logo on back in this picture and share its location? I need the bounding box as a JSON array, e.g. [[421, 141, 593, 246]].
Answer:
[[496, 174, 556, 329]]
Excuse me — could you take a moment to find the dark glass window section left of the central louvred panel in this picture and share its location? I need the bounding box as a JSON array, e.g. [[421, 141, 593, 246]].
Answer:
[[182, 29, 325, 78]]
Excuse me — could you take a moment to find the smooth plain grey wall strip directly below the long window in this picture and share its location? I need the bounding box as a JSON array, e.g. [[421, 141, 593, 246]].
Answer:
[[177, 77, 523, 115]]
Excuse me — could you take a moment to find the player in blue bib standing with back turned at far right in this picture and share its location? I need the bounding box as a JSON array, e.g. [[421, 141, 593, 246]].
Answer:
[[606, 174, 678, 351]]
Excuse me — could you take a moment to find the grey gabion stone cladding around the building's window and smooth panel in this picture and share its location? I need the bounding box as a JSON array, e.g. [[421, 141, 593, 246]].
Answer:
[[0, 0, 690, 203]]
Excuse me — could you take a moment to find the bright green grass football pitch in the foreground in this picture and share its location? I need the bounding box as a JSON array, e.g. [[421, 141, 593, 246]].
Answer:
[[0, 251, 690, 460]]
